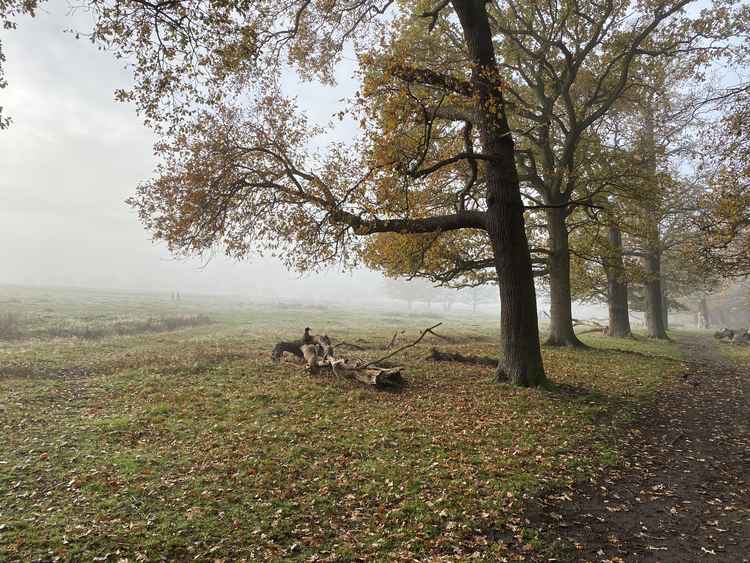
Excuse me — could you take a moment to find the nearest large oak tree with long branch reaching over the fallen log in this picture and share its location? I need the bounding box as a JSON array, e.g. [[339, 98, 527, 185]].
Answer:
[[95, 0, 545, 385]]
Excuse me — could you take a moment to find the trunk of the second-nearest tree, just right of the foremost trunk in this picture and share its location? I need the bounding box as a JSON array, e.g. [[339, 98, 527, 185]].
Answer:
[[546, 207, 584, 347]]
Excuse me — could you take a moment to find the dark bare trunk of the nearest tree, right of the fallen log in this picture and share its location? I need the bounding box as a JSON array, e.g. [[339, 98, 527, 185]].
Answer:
[[453, 0, 545, 386]]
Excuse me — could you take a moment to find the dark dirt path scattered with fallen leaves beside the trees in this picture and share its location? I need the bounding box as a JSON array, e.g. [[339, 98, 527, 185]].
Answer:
[[529, 337, 750, 562]]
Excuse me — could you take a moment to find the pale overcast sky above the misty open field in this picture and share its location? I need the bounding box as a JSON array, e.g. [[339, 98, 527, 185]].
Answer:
[[0, 3, 388, 304]]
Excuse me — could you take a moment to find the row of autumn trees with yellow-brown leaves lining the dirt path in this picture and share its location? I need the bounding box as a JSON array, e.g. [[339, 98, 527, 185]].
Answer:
[[0, 0, 748, 385]]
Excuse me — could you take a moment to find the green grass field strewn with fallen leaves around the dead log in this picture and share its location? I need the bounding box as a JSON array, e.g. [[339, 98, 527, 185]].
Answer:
[[0, 288, 681, 561]]
